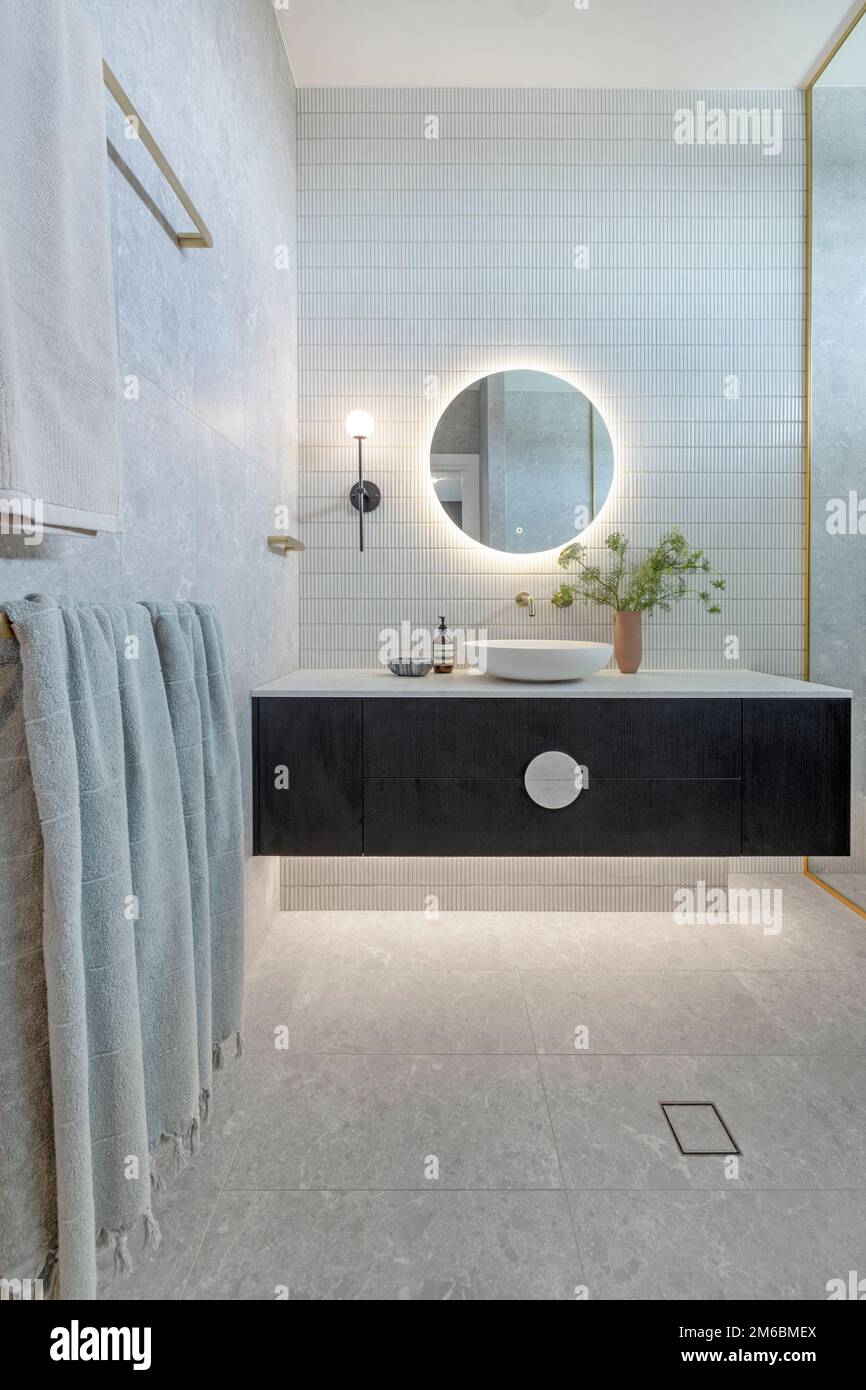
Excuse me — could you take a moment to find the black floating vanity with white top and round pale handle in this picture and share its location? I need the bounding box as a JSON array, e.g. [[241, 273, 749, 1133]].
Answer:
[[253, 670, 851, 855]]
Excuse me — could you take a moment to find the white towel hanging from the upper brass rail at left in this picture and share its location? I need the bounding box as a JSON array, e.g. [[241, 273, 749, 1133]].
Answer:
[[0, 0, 121, 531]]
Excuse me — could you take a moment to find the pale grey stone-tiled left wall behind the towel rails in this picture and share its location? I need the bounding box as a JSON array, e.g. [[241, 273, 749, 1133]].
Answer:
[[0, 0, 297, 952]]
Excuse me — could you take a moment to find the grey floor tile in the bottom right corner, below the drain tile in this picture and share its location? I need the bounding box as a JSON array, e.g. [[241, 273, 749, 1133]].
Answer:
[[569, 1191, 866, 1295]]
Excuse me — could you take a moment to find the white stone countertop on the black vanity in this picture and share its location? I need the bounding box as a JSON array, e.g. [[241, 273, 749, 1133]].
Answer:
[[252, 667, 851, 699]]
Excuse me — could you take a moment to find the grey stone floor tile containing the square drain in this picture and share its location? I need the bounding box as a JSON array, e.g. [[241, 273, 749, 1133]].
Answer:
[[539, 1055, 866, 1190]]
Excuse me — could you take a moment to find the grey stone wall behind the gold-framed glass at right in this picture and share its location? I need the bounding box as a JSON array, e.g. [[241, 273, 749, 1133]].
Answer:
[[809, 85, 866, 908]]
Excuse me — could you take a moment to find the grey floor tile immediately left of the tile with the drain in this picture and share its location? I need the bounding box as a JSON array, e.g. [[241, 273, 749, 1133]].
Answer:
[[227, 1054, 562, 1190]]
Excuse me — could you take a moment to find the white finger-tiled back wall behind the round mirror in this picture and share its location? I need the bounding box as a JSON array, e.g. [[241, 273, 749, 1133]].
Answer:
[[284, 88, 805, 908]]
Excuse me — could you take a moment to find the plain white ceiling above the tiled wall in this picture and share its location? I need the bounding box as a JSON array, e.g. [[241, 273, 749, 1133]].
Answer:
[[274, 0, 859, 88]]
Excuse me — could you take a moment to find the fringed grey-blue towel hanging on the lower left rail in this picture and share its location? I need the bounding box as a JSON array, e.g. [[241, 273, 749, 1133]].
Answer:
[[0, 598, 243, 1298]]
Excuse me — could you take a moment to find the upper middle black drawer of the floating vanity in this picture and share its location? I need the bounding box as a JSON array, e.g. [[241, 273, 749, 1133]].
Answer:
[[364, 695, 741, 780]]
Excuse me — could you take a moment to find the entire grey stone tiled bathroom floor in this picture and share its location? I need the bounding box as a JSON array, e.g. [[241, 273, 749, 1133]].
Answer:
[[100, 876, 866, 1300]]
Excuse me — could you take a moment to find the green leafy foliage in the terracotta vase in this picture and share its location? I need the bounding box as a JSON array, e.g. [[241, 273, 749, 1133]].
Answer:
[[553, 527, 726, 613]]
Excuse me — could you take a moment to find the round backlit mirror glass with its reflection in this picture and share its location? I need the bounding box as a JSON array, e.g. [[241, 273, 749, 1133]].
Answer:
[[430, 371, 613, 555]]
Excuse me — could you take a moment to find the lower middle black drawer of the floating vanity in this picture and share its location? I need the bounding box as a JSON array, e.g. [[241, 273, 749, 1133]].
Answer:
[[364, 777, 740, 855]]
